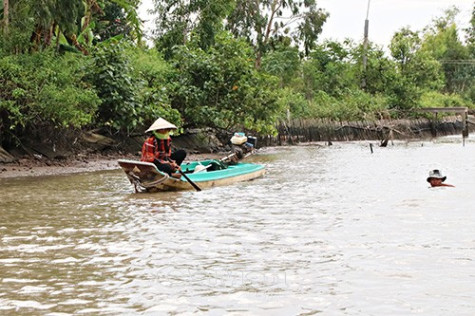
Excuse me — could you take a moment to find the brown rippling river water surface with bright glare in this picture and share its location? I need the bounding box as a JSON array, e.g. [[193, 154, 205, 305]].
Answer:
[[0, 138, 475, 315]]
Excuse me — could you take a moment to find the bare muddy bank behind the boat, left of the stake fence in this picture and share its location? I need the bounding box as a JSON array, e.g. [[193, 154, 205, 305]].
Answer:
[[0, 129, 230, 178]]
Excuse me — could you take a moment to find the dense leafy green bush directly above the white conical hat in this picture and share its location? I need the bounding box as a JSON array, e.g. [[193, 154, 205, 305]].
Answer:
[[89, 41, 181, 134]]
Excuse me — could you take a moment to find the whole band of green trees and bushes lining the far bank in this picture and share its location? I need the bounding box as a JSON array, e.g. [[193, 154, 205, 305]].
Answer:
[[0, 0, 475, 148]]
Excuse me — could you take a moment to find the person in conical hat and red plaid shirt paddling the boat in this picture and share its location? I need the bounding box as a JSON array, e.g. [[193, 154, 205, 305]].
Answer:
[[140, 118, 186, 178]]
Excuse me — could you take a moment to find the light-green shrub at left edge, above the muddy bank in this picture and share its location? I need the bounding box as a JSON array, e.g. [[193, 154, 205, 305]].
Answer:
[[0, 52, 100, 139]]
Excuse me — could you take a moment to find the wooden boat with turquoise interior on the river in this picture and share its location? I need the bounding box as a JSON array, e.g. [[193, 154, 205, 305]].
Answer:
[[118, 159, 265, 192]]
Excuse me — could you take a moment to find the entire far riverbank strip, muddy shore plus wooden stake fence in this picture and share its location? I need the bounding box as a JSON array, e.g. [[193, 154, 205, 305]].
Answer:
[[0, 117, 474, 178]]
